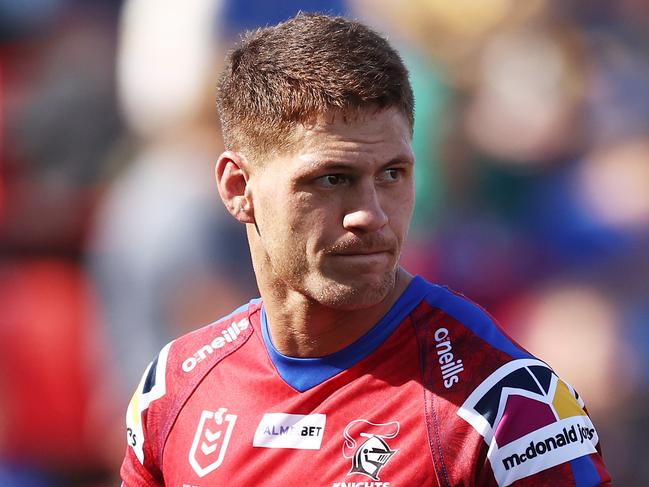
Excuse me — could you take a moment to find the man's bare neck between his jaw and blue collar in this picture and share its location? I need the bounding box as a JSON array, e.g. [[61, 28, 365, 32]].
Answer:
[[262, 269, 412, 357]]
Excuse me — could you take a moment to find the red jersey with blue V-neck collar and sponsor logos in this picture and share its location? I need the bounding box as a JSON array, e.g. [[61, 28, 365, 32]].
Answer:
[[121, 277, 610, 487]]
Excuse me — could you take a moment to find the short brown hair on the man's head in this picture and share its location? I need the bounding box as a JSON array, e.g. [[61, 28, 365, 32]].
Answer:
[[217, 13, 414, 158]]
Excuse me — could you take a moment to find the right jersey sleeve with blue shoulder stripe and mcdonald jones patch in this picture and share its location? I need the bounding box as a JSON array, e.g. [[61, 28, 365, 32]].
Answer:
[[413, 287, 611, 487]]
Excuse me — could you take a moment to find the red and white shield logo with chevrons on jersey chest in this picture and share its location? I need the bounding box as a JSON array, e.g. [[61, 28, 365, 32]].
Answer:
[[189, 408, 237, 477]]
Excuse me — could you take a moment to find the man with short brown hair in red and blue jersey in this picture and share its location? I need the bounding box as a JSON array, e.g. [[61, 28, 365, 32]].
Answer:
[[122, 15, 610, 487]]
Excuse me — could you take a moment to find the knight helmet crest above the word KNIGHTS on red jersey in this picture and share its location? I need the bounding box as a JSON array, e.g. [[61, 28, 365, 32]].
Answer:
[[343, 419, 399, 480]]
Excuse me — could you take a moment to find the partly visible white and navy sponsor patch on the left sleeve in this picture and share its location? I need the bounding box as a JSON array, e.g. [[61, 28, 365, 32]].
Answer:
[[126, 342, 173, 464]]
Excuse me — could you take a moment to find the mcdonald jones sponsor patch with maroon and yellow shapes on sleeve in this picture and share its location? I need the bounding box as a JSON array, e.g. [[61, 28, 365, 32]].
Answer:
[[457, 359, 599, 486]]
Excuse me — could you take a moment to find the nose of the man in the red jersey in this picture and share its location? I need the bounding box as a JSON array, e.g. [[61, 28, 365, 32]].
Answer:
[[343, 182, 388, 232]]
